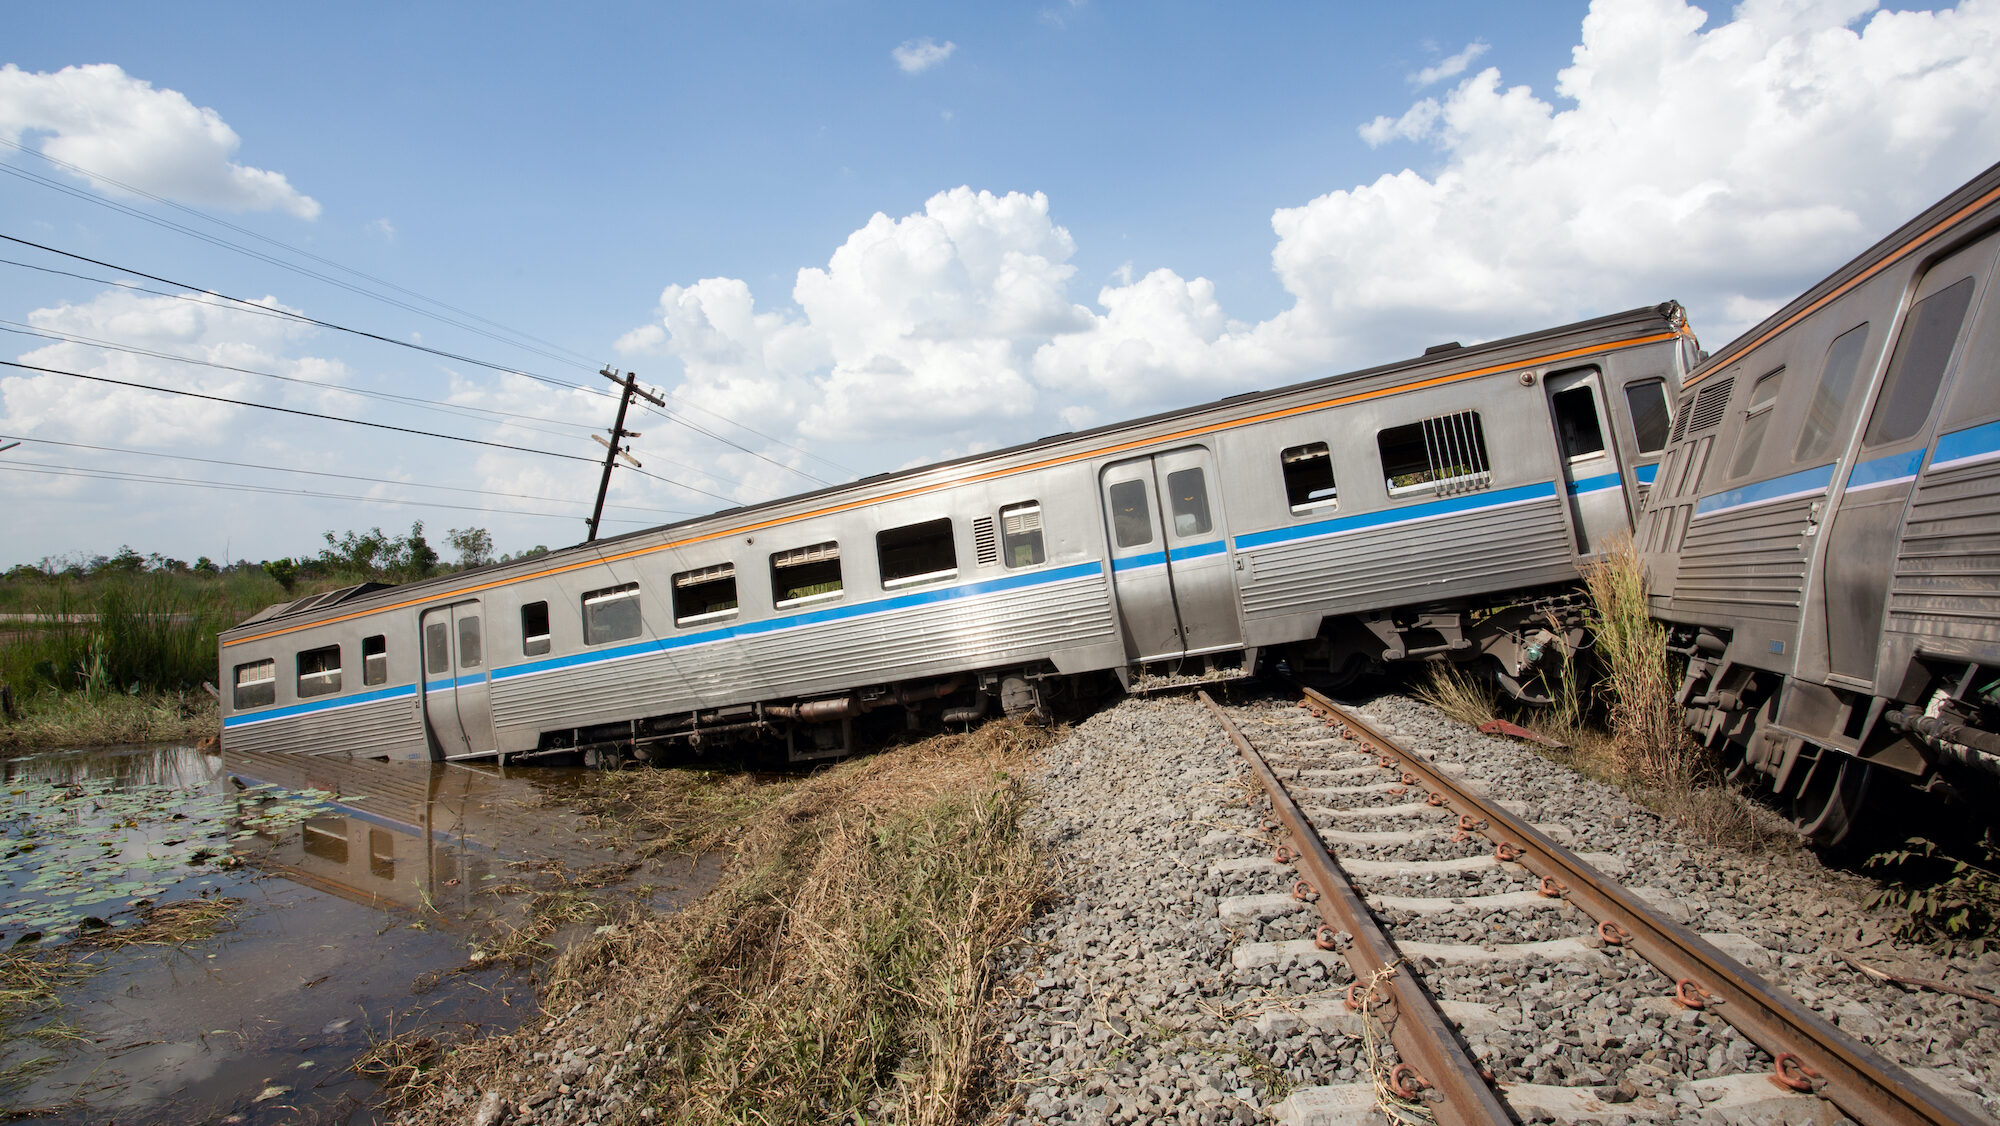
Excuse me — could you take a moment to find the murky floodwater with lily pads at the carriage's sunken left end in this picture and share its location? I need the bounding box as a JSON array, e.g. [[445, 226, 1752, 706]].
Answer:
[[0, 746, 716, 1124]]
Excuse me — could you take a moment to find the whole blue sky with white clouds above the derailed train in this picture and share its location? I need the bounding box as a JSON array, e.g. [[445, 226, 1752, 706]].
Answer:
[[0, 0, 2000, 566]]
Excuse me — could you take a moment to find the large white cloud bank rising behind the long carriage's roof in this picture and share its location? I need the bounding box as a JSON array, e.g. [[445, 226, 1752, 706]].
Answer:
[[618, 0, 2000, 486]]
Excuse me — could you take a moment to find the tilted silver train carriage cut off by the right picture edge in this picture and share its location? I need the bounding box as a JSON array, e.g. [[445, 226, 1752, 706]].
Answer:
[[1638, 166, 2000, 842]]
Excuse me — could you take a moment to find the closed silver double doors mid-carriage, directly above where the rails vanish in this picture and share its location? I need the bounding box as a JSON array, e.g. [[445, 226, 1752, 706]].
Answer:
[[1104, 446, 1242, 660]]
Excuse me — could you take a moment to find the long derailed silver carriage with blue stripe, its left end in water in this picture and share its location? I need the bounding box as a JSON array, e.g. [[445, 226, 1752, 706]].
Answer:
[[220, 304, 1696, 758]]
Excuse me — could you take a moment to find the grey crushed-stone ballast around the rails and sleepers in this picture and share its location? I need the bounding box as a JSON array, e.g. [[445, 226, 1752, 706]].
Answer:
[[990, 696, 2000, 1126]]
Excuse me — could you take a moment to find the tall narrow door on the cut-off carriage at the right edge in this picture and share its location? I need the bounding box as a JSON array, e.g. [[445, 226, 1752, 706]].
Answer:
[[1798, 240, 2000, 688]]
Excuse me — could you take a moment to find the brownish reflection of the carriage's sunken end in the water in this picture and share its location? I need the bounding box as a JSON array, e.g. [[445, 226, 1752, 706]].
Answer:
[[222, 750, 584, 910]]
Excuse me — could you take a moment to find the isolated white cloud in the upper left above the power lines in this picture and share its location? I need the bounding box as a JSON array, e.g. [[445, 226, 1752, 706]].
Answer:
[[0, 62, 320, 220]]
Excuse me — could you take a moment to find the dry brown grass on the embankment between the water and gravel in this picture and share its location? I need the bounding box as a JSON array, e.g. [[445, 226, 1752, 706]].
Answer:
[[388, 722, 1056, 1124]]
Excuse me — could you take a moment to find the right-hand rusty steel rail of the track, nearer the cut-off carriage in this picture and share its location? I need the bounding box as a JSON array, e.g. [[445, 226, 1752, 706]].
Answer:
[[1304, 688, 1990, 1126]]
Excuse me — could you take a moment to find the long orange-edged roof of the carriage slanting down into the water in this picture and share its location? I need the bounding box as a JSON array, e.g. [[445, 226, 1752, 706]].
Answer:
[[222, 300, 1686, 642]]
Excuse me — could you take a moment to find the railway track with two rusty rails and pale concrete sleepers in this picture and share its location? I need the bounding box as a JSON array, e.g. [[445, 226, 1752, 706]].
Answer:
[[1200, 690, 1984, 1126]]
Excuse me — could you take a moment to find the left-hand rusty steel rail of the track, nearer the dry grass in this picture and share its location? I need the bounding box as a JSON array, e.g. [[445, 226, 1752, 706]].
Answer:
[[1198, 692, 1514, 1126]]
